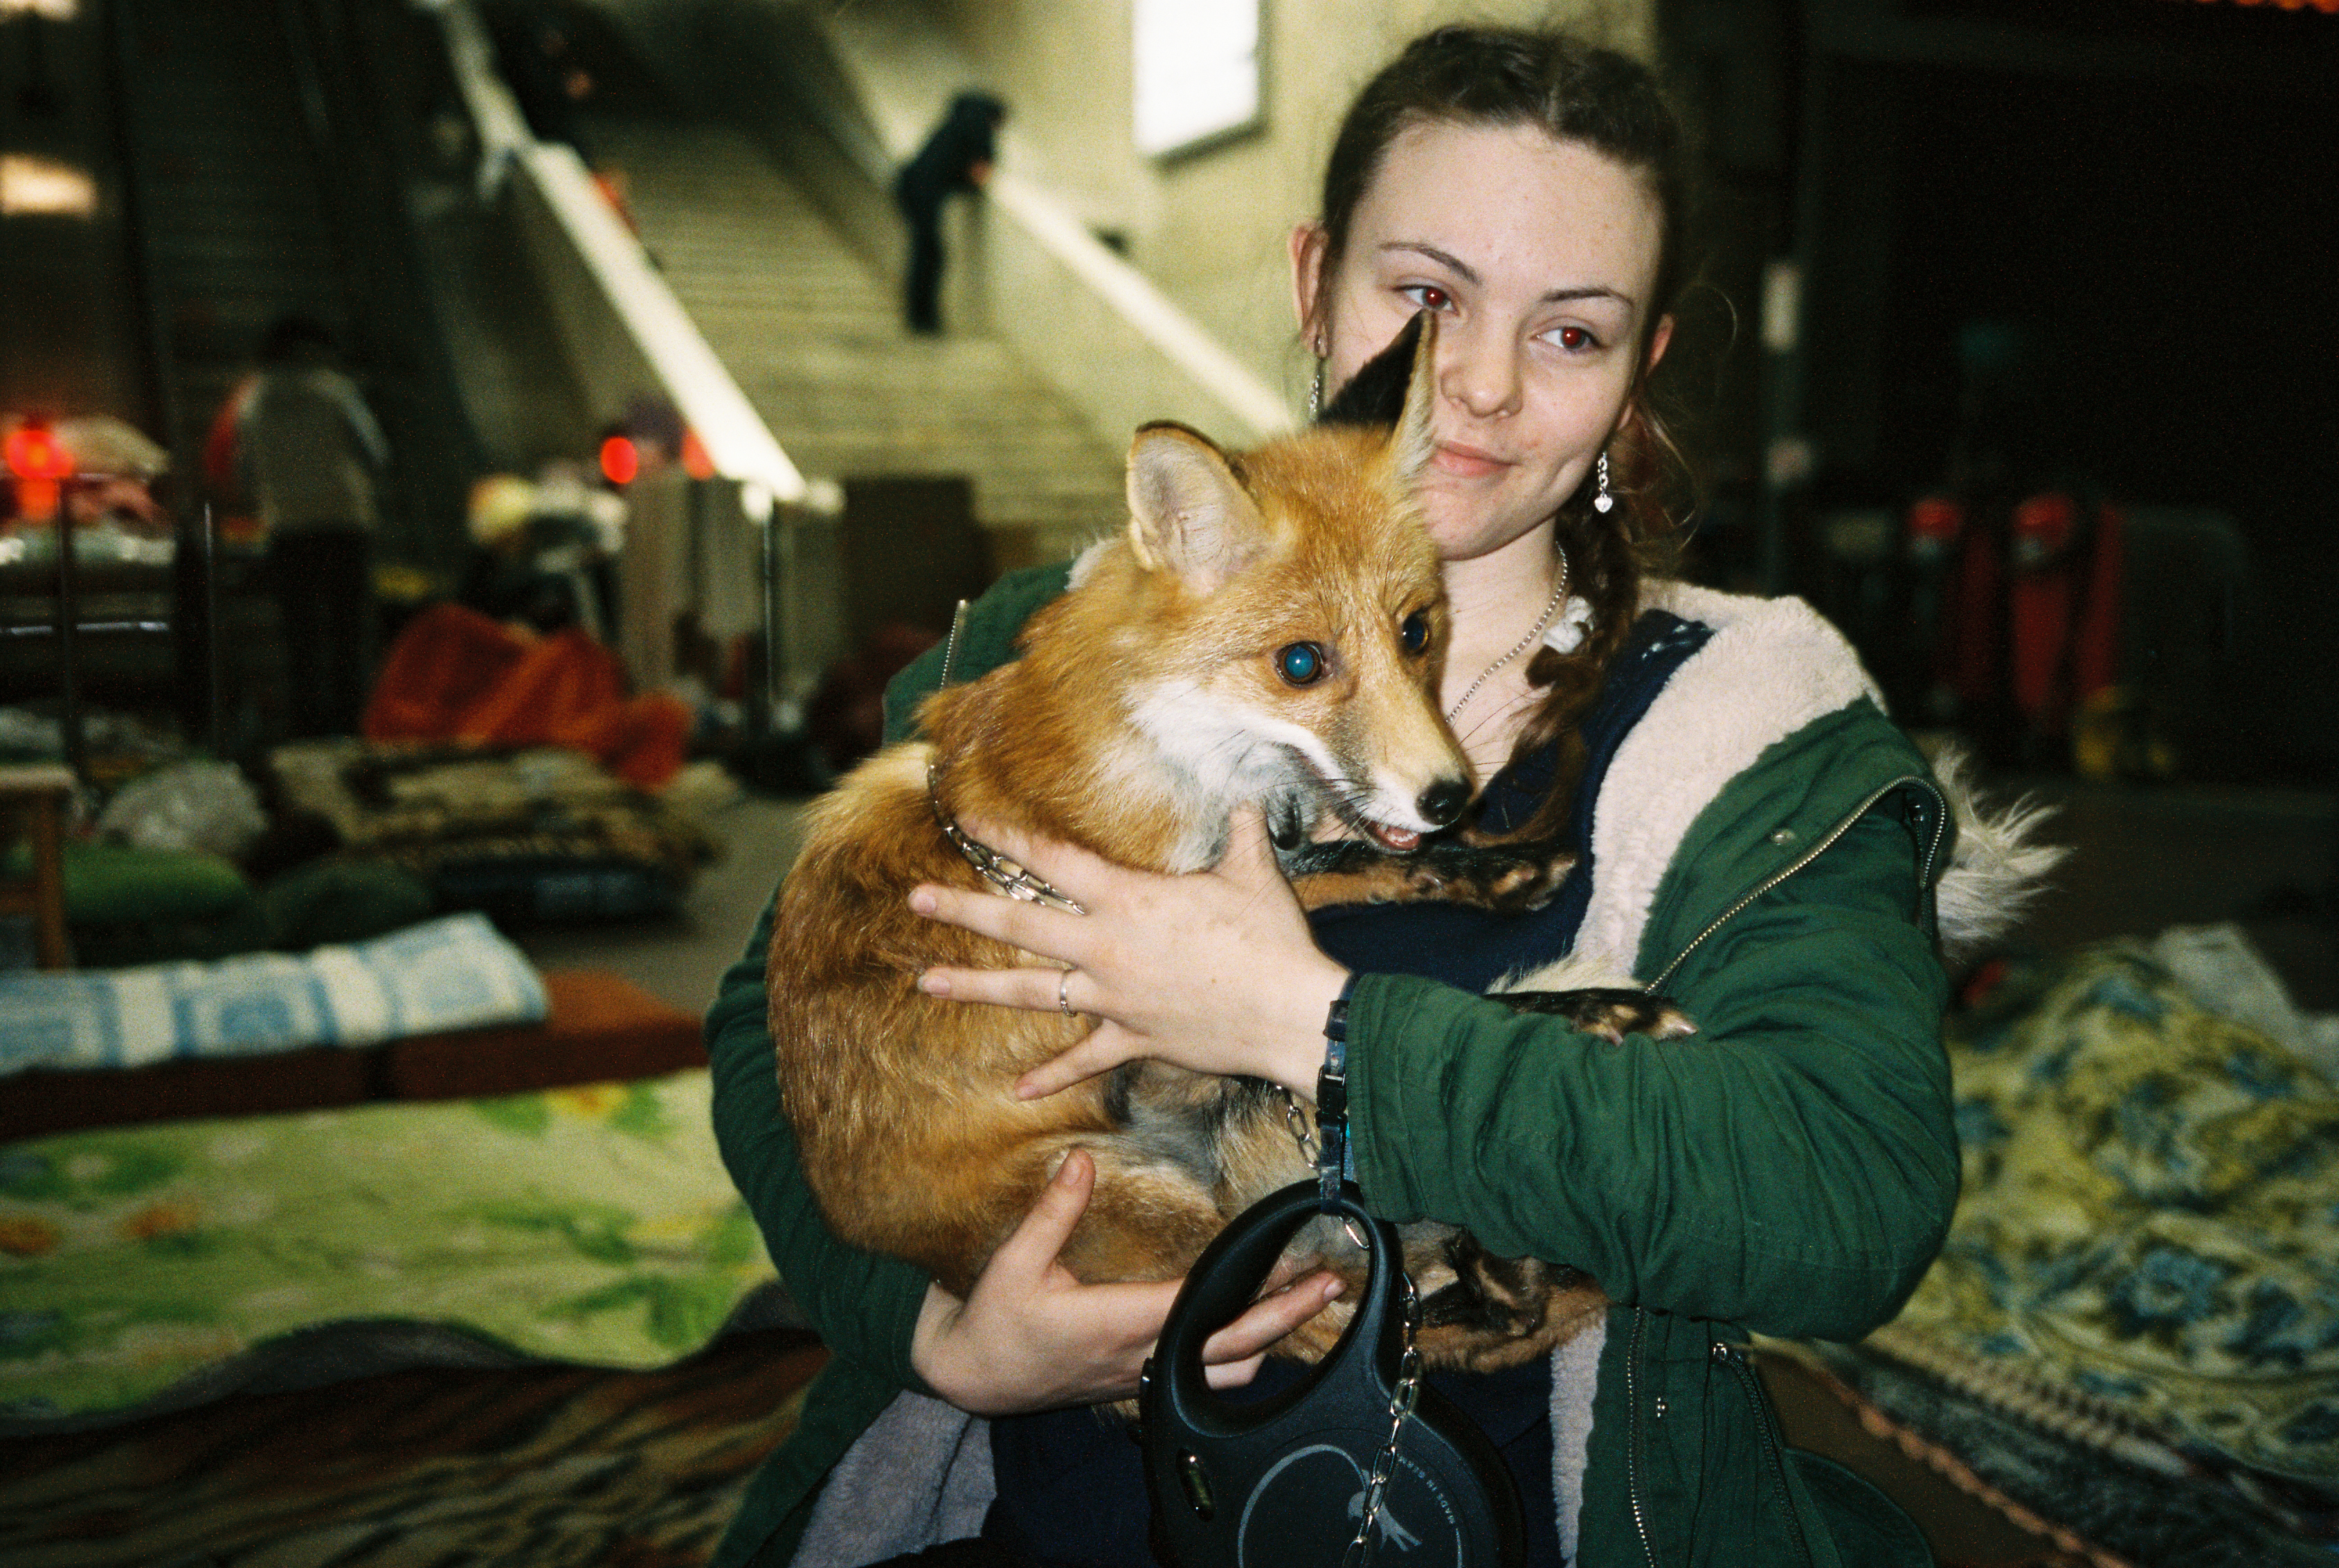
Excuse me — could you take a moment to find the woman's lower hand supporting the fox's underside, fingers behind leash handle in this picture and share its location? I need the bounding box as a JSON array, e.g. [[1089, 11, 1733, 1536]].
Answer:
[[910, 1149, 1340, 1416]]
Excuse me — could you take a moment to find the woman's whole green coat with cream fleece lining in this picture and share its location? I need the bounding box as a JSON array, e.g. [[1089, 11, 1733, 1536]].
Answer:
[[706, 566, 2021, 1568]]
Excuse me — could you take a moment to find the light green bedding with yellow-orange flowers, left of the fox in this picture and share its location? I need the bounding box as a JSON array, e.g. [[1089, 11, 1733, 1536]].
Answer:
[[0, 1070, 772, 1427]]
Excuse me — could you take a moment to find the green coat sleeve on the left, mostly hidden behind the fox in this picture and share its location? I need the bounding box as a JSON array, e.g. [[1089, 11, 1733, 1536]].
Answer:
[[706, 566, 1064, 1388]]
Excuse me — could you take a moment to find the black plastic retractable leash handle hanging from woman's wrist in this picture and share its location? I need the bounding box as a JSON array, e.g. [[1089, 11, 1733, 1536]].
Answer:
[[1137, 1182, 1525, 1568]]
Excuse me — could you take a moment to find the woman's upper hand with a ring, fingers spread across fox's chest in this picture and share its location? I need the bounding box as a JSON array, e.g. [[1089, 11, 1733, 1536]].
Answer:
[[910, 810, 1347, 1098]]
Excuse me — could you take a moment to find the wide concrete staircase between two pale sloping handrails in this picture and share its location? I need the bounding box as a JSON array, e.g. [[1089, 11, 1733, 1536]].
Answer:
[[592, 117, 1128, 568]]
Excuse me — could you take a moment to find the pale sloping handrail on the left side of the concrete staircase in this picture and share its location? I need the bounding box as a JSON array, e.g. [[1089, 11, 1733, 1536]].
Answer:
[[414, 0, 819, 510]]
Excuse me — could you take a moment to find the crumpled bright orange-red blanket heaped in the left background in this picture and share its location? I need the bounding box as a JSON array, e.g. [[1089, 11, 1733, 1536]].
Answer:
[[365, 604, 690, 788]]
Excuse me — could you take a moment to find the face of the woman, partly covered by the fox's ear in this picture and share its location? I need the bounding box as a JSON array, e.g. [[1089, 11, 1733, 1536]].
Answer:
[[1291, 122, 1672, 559]]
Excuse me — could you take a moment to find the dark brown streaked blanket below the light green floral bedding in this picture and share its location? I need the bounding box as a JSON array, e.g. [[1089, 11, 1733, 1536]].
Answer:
[[0, 1329, 826, 1568]]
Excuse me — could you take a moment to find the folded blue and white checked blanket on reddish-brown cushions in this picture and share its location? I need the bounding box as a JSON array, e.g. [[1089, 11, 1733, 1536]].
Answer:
[[0, 915, 545, 1074]]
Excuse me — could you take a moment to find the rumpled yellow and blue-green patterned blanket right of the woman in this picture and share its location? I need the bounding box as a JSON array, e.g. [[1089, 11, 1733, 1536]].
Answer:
[[1866, 941, 2339, 1490]]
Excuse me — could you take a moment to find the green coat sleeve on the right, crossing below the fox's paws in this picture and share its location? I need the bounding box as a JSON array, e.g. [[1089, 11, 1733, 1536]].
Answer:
[[1350, 753, 1958, 1339]]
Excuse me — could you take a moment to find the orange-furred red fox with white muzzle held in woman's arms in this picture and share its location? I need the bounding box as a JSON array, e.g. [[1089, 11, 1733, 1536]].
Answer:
[[770, 314, 1683, 1367]]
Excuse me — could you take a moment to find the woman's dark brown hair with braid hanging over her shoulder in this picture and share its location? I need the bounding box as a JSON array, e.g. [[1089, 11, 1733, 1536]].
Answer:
[[1317, 26, 1689, 836]]
